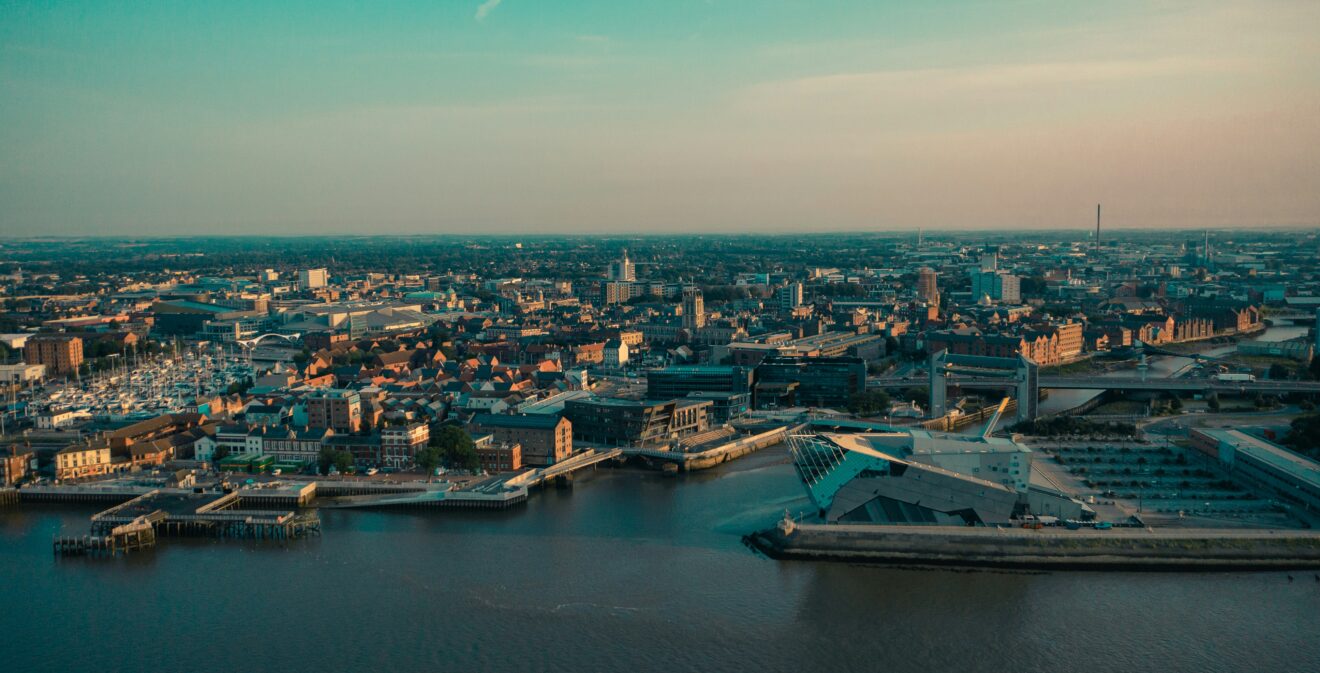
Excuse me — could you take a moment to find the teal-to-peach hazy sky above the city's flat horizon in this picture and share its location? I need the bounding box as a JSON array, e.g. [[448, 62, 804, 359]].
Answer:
[[0, 0, 1320, 236]]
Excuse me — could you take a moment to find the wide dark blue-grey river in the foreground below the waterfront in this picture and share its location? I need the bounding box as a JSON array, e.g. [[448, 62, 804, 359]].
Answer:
[[0, 447, 1320, 673]]
